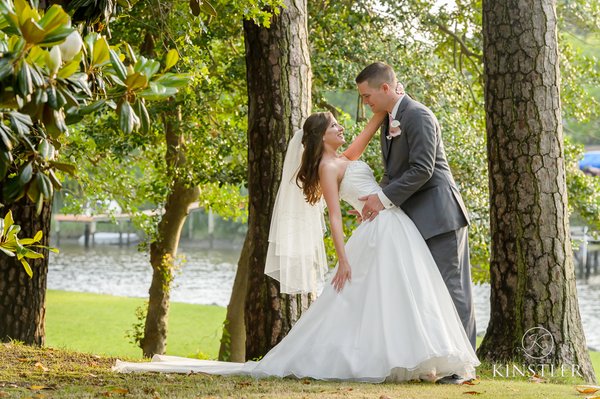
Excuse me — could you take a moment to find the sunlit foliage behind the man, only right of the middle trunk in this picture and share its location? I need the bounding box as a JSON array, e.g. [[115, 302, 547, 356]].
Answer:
[[308, 0, 600, 282]]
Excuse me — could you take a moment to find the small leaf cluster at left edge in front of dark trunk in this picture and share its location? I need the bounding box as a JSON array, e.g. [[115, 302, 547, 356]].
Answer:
[[0, 211, 58, 278]]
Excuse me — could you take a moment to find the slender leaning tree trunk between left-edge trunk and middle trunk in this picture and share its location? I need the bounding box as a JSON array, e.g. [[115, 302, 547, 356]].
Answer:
[[140, 107, 200, 357]]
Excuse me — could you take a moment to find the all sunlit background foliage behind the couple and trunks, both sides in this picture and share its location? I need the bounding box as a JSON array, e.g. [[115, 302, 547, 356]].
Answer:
[[55, 0, 600, 282]]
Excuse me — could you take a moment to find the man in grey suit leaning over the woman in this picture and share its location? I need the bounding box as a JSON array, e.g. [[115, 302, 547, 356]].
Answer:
[[356, 62, 476, 349]]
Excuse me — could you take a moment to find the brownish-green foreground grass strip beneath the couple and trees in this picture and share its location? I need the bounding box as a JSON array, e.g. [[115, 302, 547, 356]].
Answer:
[[0, 343, 590, 399]]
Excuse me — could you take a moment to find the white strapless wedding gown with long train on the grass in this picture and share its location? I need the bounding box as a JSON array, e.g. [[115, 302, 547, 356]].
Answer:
[[113, 161, 479, 382]]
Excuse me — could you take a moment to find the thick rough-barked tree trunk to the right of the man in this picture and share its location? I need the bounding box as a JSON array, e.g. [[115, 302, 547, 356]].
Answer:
[[478, 0, 595, 381]]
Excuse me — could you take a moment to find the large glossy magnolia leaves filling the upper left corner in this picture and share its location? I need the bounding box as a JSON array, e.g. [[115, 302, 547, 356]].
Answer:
[[0, 0, 188, 216]]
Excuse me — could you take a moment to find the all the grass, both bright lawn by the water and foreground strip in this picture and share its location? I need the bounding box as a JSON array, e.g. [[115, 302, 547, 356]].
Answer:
[[32, 291, 600, 399]]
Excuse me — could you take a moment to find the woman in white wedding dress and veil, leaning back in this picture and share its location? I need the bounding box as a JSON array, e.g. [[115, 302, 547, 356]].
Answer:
[[113, 112, 479, 382]]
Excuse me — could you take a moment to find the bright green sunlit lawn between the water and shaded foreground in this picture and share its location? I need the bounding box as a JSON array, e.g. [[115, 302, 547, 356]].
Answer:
[[46, 290, 225, 359]]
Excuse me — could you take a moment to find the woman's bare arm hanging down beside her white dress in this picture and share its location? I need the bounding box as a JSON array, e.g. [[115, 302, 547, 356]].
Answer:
[[319, 164, 352, 292]]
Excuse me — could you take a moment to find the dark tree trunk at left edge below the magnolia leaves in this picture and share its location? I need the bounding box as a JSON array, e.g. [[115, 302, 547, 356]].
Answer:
[[0, 197, 52, 346]]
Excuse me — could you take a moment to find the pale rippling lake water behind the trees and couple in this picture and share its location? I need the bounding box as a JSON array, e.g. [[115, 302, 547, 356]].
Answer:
[[48, 243, 600, 350]]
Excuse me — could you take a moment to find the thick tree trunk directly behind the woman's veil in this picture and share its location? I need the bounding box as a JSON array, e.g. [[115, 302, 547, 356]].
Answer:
[[218, 0, 311, 360]]
